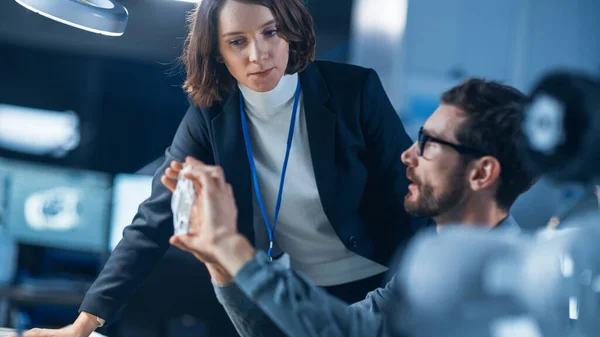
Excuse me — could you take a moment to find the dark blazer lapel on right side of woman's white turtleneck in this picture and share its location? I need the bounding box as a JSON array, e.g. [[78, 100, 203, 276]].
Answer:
[[300, 63, 338, 231]]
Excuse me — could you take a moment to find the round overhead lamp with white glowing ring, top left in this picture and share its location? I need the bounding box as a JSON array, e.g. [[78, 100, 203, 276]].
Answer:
[[15, 0, 129, 36]]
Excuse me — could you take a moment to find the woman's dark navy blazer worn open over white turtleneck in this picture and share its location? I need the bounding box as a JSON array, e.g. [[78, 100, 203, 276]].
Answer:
[[80, 61, 413, 319]]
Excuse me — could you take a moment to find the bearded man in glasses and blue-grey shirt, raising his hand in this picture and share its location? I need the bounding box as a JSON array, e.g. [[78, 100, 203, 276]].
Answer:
[[166, 79, 534, 337]]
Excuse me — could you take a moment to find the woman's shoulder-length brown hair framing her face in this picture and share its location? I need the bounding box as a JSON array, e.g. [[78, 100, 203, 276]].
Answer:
[[182, 0, 316, 107]]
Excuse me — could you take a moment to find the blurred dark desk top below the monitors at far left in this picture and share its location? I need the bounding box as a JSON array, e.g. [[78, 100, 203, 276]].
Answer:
[[0, 286, 85, 306]]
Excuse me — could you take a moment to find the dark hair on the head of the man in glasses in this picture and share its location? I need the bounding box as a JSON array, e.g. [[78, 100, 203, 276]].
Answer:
[[442, 78, 536, 209]]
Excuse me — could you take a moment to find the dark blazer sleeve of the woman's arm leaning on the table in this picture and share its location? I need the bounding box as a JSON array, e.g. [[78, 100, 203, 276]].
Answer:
[[79, 105, 214, 321]]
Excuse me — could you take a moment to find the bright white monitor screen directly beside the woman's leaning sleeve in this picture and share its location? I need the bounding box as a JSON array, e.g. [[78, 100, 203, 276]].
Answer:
[[108, 174, 152, 252]]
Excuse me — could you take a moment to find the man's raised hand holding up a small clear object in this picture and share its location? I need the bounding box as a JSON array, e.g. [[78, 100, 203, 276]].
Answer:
[[169, 157, 238, 263]]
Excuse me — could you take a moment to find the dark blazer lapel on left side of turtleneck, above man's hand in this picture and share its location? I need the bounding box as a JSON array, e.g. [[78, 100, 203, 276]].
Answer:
[[211, 87, 254, 242]]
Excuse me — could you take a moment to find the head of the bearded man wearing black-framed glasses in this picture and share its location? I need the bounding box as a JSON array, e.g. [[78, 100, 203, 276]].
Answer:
[[401, 79, 534, 229]]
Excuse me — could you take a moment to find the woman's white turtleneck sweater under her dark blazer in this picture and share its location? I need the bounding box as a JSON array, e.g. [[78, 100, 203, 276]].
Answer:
[[238, 74, 387, 286]]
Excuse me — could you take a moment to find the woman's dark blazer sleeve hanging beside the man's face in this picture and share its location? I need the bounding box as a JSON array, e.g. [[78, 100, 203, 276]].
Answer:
[[360, 69, 426, 245]]
